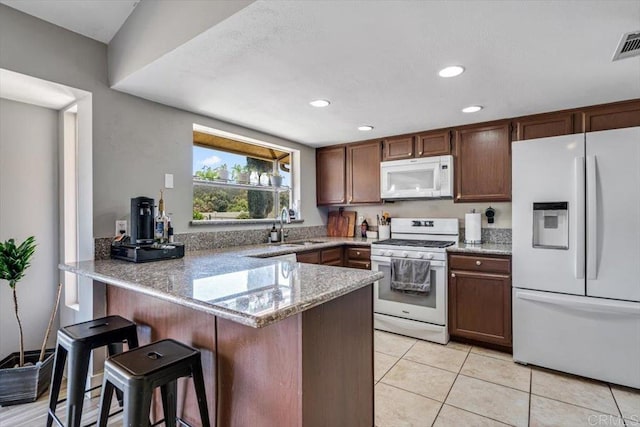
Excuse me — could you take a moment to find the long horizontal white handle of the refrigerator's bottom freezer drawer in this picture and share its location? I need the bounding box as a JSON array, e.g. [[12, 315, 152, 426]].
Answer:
[[516, 290, 640, 319]]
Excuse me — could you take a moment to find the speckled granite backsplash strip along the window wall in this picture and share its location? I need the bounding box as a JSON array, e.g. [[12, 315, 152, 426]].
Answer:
[[95, 225, 327, 259]]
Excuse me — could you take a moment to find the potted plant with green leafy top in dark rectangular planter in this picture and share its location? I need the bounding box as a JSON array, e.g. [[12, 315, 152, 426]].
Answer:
[[0, 236, 62, 406]]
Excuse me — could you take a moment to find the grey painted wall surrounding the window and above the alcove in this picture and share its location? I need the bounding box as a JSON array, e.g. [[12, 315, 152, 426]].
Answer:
[[0, 5, 325, 241]]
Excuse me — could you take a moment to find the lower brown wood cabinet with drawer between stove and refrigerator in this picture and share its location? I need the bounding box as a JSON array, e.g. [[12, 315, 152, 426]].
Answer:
[[448, 254, 512, 348]]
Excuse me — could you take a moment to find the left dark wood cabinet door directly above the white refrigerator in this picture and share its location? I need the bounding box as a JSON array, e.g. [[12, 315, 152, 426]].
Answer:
[[513, 112, 577, 141]]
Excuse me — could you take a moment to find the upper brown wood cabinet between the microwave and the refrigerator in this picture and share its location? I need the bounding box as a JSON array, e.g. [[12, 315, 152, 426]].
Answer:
[[454, 122, 511, 202]]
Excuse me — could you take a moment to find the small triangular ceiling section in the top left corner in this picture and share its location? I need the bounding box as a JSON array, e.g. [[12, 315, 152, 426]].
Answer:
[[0, 0, 140, 43]]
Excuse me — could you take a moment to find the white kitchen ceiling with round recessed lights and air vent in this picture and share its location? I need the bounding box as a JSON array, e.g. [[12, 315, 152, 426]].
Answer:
[[2, 0, 640, 146]]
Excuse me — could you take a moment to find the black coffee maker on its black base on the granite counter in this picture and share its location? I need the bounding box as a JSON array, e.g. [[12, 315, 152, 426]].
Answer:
[[111, 197, 184, 262]]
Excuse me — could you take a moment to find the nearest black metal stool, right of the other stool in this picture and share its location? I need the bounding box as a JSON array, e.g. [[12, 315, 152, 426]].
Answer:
[[98, 339, 210, 427]]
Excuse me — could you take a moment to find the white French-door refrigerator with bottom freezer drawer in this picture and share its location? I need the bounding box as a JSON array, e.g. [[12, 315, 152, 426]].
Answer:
[[512, 127, 640, 388]]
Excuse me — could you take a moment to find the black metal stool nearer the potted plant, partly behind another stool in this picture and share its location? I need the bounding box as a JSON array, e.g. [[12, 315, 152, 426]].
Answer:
[[47, 316, 138, 427]]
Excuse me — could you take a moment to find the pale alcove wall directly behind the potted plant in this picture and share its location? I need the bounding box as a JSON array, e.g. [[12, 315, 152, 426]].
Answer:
[[0, 99, 58, 357]]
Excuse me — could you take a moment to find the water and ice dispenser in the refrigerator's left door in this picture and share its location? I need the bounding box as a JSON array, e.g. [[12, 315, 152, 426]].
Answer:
[[533, 202, 569, 249]]
